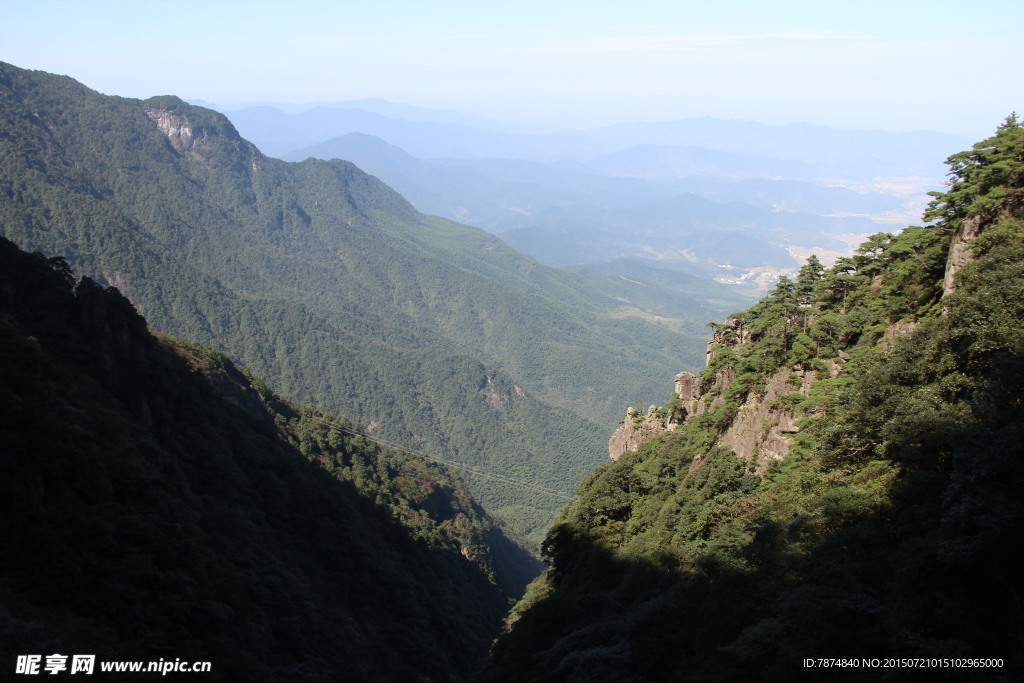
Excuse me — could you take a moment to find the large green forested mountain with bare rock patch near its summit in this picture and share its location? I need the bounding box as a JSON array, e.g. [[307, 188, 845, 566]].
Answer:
[[0, 63, 721, 543]]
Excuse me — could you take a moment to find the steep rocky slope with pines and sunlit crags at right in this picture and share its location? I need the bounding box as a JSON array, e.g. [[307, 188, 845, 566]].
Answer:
[[488, 117, 1024, 683]]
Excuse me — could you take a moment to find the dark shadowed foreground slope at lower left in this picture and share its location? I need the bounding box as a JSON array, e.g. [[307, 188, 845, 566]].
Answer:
[[0, 233, 538, 681]]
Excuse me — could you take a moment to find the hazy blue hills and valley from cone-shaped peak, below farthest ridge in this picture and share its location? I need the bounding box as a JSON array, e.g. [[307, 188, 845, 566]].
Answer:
[[285, 124, 939, 276]]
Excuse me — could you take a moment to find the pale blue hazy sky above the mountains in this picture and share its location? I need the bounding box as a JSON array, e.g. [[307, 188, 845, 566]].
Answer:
[[0, 0, 1024, 139]]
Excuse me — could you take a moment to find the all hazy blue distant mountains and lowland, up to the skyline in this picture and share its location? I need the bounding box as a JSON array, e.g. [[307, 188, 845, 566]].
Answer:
[[270, 110, 950, 287]]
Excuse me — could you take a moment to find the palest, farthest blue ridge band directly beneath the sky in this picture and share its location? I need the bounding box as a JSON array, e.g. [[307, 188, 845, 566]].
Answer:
[[226, 101, 970, 167]]
